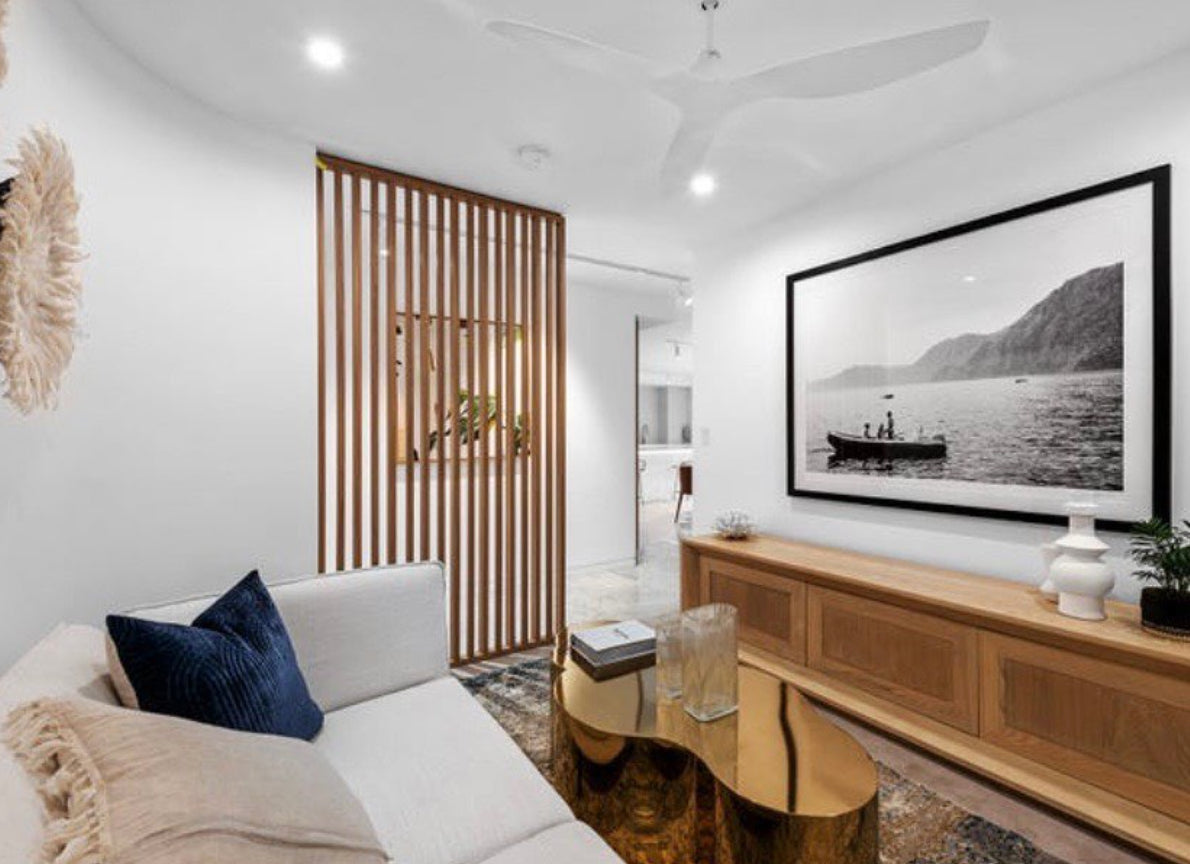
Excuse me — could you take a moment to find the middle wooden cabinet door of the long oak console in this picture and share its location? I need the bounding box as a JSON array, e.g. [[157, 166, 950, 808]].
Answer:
[[807, 586, 979, 734]]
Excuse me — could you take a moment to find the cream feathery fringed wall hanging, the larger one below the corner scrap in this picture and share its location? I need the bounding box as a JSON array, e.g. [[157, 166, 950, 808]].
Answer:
[[0, 126, 82, 414]]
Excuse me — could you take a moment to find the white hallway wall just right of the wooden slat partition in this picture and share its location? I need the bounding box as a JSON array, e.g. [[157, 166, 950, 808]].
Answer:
[[566, 282, 675, 568]]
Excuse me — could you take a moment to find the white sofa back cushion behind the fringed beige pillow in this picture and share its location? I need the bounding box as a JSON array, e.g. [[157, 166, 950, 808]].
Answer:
[[0, 625, 117, 862]]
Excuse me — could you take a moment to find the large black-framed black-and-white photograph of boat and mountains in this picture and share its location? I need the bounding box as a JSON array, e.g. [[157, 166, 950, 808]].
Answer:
[[787, 165, 1171, 530]]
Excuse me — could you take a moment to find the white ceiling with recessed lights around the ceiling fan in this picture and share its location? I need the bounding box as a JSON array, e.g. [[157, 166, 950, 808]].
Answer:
[[74, 0, 1190, 273]]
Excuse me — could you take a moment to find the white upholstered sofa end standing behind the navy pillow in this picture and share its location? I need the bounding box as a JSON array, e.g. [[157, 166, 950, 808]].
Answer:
[[127, 563, 449, 710]]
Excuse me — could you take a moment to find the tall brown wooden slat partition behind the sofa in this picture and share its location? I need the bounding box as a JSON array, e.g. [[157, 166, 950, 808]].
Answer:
[[315, 155, 565, 664]]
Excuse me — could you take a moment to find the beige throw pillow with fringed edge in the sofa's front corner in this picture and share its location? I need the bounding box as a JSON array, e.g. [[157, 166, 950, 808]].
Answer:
[[4, 699, 389, 864]]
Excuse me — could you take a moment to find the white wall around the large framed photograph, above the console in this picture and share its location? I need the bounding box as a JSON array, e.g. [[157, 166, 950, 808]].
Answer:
[[695, 47, 1190, 599]]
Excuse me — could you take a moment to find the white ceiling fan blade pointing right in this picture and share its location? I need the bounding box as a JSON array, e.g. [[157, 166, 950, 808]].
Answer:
[[732, 21, 991, 102]]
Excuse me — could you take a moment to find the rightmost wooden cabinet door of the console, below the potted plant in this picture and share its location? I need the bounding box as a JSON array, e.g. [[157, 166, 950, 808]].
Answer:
[[981, 632, 1190, 821]]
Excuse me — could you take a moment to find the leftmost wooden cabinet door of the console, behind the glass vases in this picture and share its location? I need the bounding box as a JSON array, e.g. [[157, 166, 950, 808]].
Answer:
[[700, 558, 806, 663]]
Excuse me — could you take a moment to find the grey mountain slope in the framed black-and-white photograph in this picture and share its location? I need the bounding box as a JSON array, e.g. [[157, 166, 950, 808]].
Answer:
[[816, 262, 1123, 388]]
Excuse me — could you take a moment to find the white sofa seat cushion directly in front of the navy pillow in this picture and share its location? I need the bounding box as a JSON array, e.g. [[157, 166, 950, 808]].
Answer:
[[315, 677, 574, 864]]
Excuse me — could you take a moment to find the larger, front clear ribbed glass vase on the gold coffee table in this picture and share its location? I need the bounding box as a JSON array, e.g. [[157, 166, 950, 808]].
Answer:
[[682, 603, 739, 722]]
